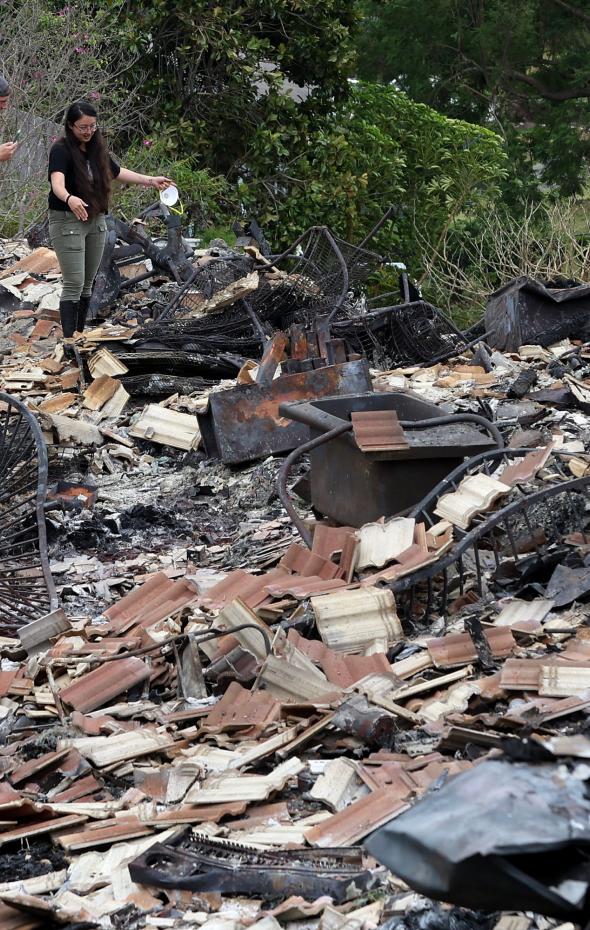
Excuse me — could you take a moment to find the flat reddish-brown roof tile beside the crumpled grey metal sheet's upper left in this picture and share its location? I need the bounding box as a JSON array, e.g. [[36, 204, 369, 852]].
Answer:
[[305, 786, 408, 847]]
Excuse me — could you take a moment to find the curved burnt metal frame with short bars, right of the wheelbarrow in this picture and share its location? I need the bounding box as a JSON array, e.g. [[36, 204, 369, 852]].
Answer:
[[387, 449, 590, 620]]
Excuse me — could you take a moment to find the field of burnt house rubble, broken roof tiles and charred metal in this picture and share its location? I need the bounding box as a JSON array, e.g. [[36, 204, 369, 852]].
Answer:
[[0, 227, 590, 930]]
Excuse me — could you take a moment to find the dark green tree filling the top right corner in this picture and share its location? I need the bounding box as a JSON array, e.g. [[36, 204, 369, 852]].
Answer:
[[358, 0, 590, 199]]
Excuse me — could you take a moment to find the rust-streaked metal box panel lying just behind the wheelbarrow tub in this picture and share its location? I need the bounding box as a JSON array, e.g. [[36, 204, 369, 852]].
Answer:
[[197, 360, 371, 464]]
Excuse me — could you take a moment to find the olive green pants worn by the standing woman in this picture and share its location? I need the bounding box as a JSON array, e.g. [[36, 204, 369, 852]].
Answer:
[[49, 210, 107, 301]]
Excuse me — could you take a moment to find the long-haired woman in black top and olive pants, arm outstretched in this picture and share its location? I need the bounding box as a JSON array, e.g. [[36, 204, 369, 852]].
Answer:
[[49, 100, 172, 339]]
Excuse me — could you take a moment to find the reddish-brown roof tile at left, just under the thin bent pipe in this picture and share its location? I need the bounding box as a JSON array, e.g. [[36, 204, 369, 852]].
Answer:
[[60, 656, 150, 714]]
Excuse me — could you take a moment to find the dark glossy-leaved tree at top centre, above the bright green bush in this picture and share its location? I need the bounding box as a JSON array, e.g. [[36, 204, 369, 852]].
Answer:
[[101, 0, 359, 175]]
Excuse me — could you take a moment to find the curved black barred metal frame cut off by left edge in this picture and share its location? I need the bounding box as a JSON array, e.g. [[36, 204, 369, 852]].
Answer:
[[0, 393, 58, 630]]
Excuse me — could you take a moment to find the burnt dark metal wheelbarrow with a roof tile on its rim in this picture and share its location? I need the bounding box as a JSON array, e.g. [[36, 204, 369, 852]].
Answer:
[[279, 392, 503, 532]]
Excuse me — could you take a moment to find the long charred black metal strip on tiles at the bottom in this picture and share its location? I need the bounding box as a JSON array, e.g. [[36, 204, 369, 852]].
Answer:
[[129, 832, 380, 903]]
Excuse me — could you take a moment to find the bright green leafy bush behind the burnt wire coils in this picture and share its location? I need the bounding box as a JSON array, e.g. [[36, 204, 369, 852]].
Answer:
[[240, 83, 506, 274]]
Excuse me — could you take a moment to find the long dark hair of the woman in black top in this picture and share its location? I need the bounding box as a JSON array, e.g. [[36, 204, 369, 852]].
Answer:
[[62, 100, 113, 217]]
